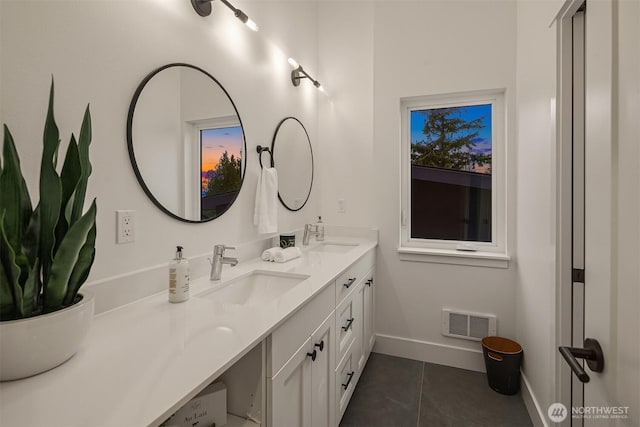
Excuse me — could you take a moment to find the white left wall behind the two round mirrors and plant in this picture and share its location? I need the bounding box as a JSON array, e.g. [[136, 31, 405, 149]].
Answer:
[[0, 0, 319, 310]]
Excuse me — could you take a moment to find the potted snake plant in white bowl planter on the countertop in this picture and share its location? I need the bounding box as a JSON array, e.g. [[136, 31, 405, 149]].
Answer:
[[0, 80, 96, 381]]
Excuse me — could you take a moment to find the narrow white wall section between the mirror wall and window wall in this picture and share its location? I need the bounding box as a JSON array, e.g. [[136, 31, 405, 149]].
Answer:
[[312, 1, 376, 226]]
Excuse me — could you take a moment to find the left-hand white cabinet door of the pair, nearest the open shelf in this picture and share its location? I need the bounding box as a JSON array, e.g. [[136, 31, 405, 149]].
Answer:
[[269, 338, 312, 427]]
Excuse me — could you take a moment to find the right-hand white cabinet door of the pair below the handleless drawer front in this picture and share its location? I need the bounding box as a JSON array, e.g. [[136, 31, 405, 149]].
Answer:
[[311, 312, 336, 427]]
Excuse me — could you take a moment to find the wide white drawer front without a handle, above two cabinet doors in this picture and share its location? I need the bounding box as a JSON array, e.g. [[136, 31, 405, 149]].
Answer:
[[266, 285, 335, 377]]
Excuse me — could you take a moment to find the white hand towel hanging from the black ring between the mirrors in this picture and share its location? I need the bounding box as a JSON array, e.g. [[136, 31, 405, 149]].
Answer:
[[253, 168, 278, 234]]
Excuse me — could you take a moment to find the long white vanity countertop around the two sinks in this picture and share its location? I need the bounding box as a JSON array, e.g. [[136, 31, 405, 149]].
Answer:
[[0, 237, 376, 427]]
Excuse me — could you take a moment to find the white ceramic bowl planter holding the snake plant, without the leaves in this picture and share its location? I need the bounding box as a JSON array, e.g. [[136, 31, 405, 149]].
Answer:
[[0, 291, 94, 381]]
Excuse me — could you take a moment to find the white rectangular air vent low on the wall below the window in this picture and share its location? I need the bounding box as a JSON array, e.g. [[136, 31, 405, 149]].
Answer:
[[442, 308, 497, 341]]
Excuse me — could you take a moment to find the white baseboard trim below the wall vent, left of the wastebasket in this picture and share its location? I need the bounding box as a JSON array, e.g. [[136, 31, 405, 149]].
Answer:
[[373, 334, 486, 372]]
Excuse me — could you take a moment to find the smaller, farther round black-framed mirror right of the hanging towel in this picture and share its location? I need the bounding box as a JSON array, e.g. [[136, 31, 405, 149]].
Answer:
[[271, 117, 313, 212]]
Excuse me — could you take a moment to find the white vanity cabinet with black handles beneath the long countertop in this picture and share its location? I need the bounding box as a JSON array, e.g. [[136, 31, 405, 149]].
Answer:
[[266, 250, 375, 427]]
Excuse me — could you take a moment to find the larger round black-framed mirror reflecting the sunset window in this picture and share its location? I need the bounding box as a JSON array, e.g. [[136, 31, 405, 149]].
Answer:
[[127, 63, 246, 223]]
